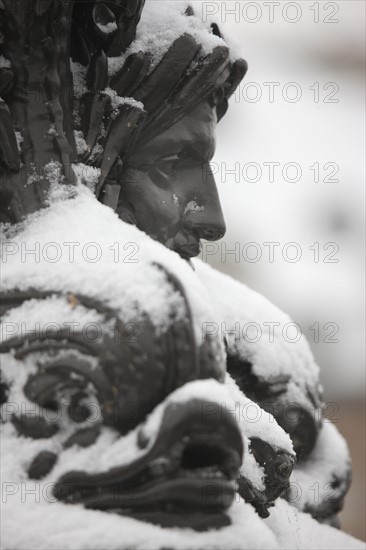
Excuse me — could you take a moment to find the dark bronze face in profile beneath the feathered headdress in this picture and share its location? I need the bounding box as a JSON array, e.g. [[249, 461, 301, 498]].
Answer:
[[117, 103, 225, 258]]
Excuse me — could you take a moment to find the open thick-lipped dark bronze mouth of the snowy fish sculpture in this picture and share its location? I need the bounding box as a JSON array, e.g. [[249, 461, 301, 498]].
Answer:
[[54, 401, 243, 529]]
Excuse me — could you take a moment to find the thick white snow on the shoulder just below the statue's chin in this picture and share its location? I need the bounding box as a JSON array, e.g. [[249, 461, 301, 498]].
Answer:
[[194, 260, 319, 394]]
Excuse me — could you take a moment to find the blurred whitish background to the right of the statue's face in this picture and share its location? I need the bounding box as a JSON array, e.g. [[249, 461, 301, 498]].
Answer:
[[200, 0, 365, 397]]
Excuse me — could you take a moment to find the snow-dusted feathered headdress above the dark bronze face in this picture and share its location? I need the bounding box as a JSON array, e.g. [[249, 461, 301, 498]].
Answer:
[[0, 0, 246, 223]]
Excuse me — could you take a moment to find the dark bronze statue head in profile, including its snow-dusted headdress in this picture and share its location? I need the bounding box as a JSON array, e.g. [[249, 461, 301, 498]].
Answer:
[[0, 0, 246, 258]]
